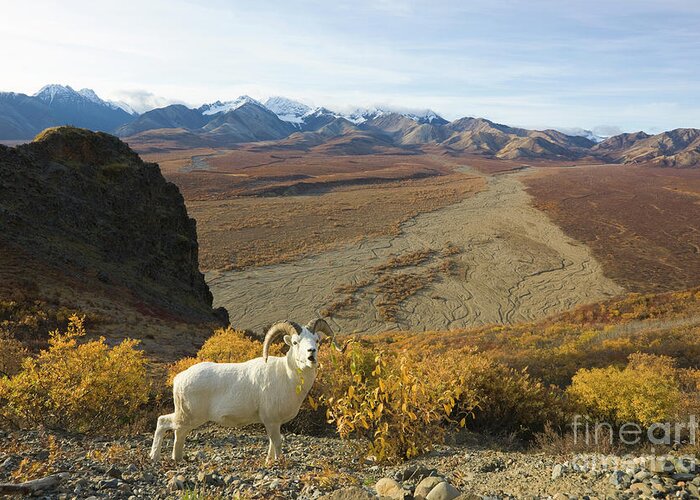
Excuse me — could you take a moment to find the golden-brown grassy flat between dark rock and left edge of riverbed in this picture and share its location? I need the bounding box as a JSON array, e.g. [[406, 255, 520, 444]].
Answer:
[[187, 174, 483, 270]]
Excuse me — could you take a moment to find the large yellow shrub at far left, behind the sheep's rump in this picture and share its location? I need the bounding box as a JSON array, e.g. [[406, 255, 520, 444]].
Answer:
[[0, 316, 149, 432]]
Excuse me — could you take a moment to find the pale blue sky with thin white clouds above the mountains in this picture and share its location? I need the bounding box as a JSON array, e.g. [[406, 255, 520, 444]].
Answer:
[[0, 0, 700, 135]]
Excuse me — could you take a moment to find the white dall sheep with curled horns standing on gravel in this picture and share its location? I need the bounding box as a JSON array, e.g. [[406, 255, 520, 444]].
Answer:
[[150, 318, 347, 463]]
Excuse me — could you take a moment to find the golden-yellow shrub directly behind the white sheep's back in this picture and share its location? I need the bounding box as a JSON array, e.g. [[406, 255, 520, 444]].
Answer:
[[168, 327, 283, 385]]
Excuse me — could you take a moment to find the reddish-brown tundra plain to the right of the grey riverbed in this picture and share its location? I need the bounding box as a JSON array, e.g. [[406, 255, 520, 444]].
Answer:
[[526, 165, 700, 292]]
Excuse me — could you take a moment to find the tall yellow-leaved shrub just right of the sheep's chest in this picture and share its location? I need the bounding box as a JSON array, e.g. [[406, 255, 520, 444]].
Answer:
[[323, 352, 460, 461]]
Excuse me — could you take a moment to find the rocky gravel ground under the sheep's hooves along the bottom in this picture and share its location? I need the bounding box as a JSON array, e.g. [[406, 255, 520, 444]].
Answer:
[[0, 426, 700, 500]]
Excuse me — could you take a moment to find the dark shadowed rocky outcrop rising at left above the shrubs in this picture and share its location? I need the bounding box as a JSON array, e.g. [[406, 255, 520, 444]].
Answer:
[[0, 127, 212, 317]]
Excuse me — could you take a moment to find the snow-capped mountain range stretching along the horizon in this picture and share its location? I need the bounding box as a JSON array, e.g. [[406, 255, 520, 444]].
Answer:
[[0, 85, 700, 167]]
